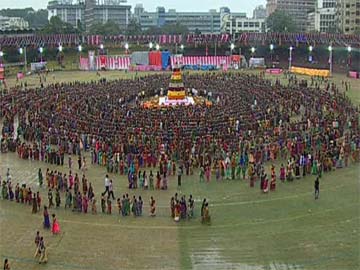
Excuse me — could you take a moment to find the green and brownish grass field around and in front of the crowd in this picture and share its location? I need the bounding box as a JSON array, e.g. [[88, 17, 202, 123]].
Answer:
[[0, 72, 360, 270]]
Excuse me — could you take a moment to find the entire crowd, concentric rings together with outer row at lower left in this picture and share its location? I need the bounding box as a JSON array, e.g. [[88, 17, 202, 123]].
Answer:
[[0, 73, 360, 226]]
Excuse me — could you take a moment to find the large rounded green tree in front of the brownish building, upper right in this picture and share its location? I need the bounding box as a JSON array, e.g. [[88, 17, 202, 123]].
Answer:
[[266, 10, 297, 33]]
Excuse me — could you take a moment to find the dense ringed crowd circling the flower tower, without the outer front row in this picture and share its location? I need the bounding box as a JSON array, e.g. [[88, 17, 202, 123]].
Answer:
[[0, 72, 360, 174]]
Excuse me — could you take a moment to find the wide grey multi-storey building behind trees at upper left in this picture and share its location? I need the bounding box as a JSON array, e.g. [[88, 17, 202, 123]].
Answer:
[[47, 0, 131, 31]]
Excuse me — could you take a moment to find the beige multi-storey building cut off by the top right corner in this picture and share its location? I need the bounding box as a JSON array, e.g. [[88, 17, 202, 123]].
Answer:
[[336, 0, 360, 34]]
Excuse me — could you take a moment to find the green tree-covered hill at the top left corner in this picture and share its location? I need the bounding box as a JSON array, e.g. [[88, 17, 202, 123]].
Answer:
[[0, 8, 48, 28]]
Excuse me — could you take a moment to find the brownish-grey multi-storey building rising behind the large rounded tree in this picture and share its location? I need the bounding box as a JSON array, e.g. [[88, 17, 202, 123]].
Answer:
[[266, 0, 317, 31]]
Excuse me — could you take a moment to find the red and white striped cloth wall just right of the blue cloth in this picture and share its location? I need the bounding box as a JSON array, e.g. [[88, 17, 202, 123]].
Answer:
[[171, 56, 231, 67]]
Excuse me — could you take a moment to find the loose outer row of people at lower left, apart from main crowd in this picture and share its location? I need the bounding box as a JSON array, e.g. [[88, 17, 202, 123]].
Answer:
[[1, 163, 215, 225]]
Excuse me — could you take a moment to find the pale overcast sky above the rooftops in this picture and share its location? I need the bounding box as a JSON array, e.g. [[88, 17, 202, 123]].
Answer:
[[0, 0, 266, 16]]
